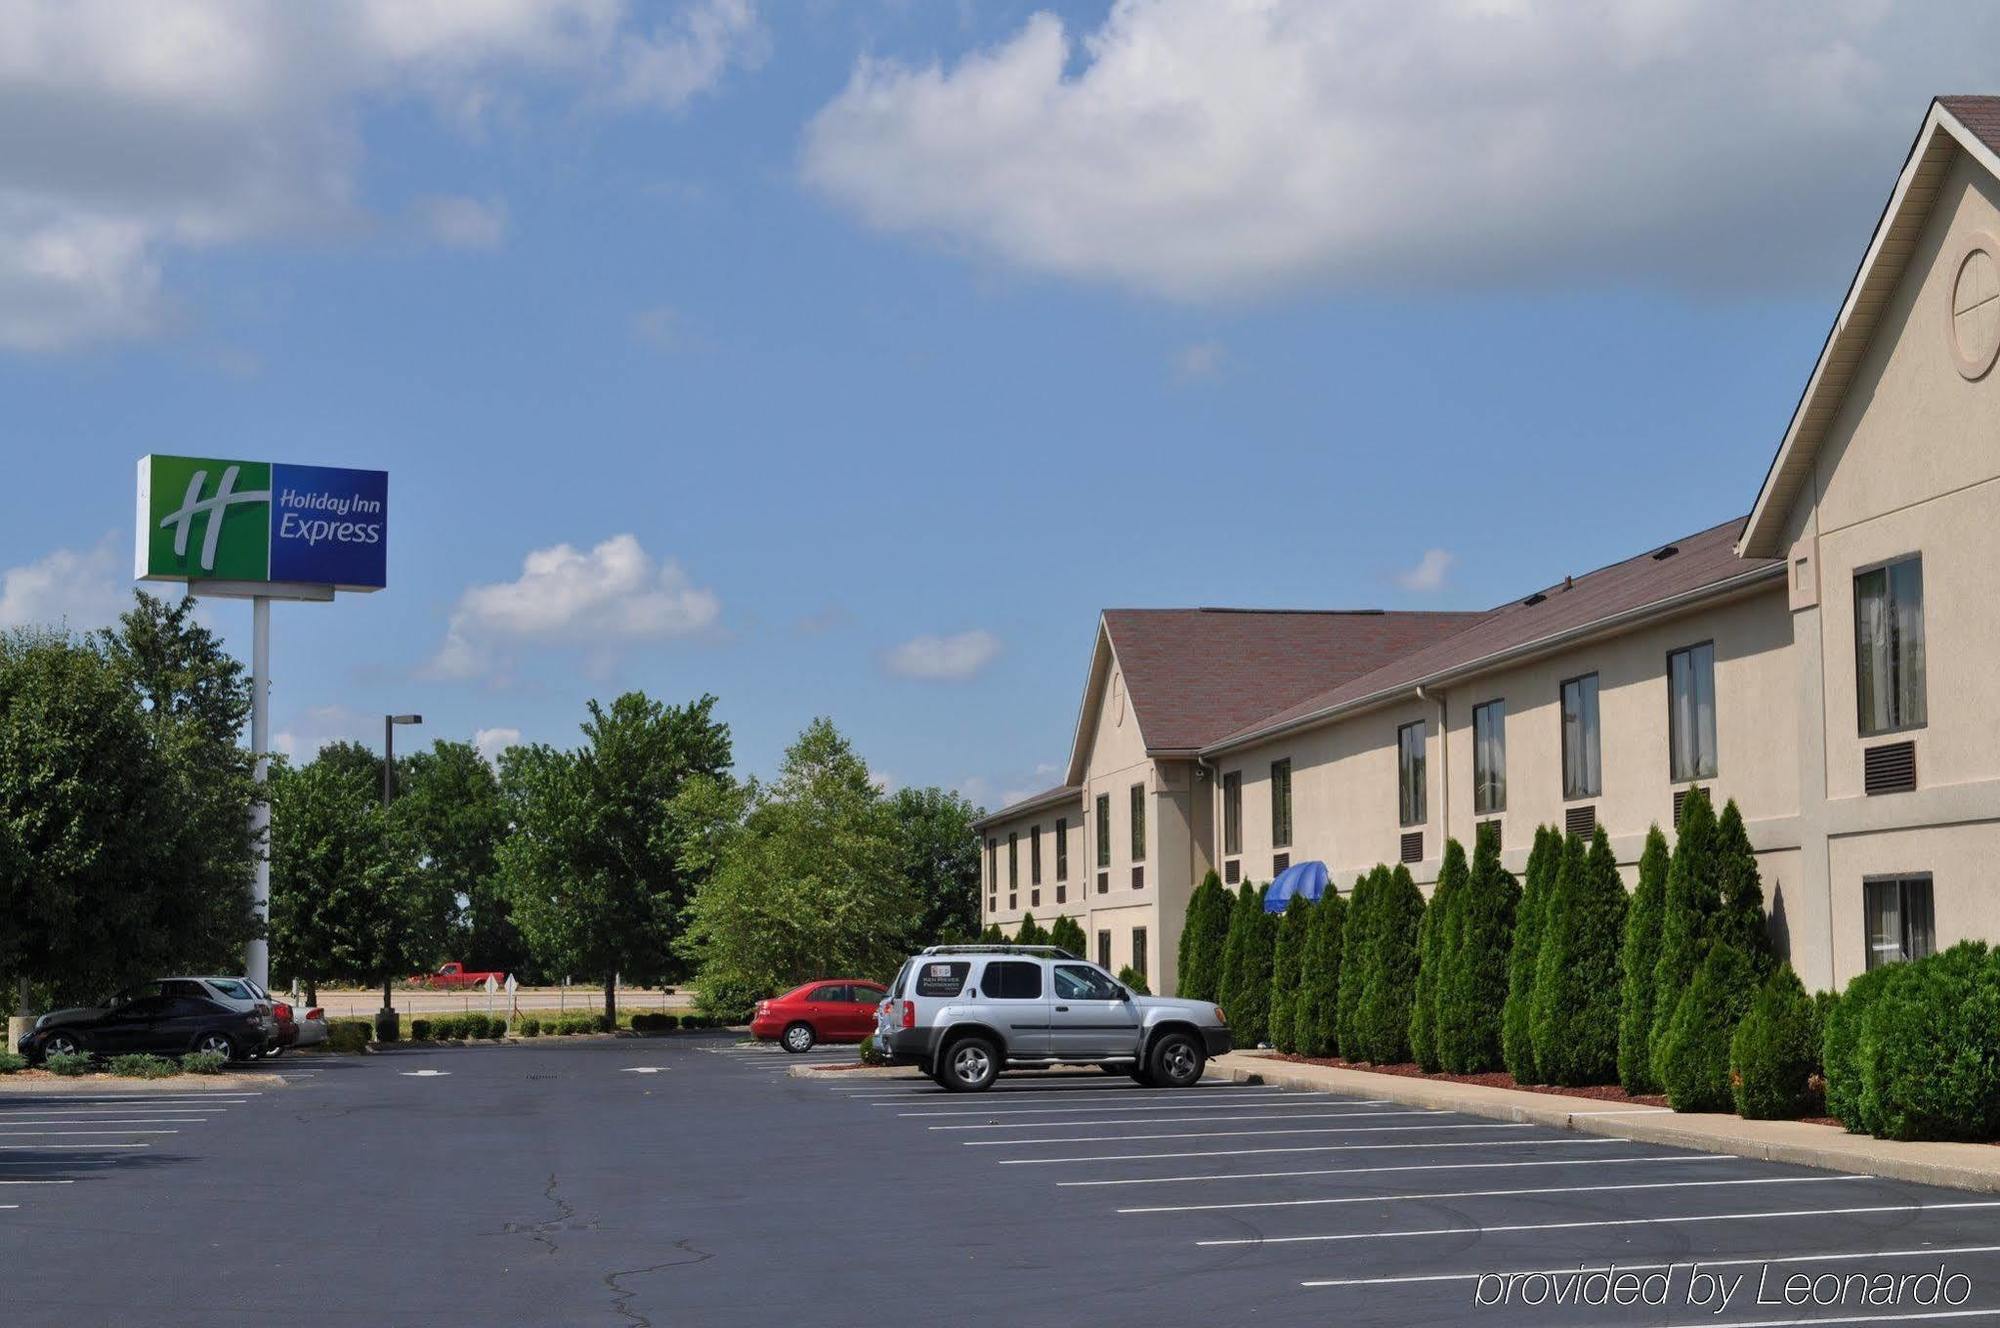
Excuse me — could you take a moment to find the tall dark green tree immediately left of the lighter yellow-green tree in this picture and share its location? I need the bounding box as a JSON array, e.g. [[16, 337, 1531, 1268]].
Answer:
[[500, 692, 740, 1022]]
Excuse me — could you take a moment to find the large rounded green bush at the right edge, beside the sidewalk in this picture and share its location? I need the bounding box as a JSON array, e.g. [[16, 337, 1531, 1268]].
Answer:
[[1858, 940, 2000, 1140]]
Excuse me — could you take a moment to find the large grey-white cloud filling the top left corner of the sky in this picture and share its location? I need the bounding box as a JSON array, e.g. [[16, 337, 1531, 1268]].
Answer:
[[0, 0, 766, 352]]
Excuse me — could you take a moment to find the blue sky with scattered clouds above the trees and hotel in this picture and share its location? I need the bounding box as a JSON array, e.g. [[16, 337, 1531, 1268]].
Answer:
[[0, 0, 2000, 806]]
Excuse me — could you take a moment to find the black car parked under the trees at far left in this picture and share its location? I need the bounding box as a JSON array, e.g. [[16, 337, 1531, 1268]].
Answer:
[[20, 978, 268, 1062]]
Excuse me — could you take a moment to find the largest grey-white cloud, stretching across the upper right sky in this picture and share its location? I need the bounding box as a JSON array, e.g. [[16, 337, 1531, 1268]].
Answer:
[[802, 0, 2000, 300]]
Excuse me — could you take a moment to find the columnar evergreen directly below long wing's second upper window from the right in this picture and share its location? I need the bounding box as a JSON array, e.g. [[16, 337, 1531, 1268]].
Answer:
[[1530, 826, 1626, 1086]]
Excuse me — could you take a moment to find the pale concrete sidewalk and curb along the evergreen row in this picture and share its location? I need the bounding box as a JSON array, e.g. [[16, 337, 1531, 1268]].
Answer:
[[1208, 1052, 2000, 1192]]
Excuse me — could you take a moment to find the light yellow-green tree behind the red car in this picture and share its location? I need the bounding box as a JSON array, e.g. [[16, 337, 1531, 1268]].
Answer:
[[686, 718, 916, 1016]]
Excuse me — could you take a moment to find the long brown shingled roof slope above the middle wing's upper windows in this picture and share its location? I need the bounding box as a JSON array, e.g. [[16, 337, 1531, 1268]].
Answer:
[[1200, 516, 1782, 748]]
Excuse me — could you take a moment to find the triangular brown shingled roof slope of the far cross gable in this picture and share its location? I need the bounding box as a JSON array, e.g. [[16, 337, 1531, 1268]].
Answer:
[[1104, 608, 1484, 752]]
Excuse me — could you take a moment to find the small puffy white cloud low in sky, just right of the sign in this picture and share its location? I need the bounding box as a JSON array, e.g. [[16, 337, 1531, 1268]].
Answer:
[[428, 534, 722, 678]]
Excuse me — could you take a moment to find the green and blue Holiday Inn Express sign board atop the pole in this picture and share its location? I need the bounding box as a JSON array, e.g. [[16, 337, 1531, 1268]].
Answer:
[[134, 456, 388, 590]]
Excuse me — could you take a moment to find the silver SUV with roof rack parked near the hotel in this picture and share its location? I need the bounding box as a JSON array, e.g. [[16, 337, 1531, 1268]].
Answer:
[[876, 946, 1230, 1092]]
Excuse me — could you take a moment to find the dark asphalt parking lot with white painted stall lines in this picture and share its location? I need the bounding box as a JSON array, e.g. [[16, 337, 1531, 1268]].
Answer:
[[0, 1036, 2000, 1328]]
